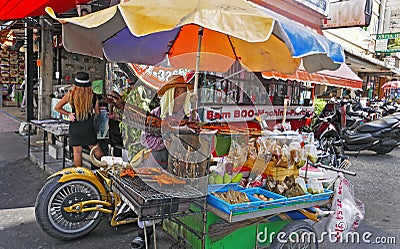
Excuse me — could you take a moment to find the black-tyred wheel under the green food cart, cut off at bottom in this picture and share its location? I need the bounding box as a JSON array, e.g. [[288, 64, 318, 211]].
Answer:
[[269, 220, 318, 249]]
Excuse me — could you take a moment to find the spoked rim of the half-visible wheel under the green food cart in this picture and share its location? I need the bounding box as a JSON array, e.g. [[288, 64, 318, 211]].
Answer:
[[281, 229, 317, 249]]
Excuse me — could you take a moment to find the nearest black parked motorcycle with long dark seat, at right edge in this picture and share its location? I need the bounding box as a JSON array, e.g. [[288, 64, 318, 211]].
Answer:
[[313, 100, 400, 154]]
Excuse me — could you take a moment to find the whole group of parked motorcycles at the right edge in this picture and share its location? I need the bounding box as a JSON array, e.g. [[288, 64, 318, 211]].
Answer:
[[302, 99, 400, 160]]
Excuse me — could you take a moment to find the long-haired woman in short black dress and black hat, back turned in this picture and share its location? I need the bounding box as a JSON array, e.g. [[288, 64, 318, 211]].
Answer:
[[54, 72, 103, 166]]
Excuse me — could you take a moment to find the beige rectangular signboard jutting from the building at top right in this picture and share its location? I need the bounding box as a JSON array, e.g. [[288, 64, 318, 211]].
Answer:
[[322, 0, 373, 29]]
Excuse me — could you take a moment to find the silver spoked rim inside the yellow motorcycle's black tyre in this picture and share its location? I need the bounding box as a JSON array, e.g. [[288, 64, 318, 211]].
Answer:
[[47, 181, 100, 233]]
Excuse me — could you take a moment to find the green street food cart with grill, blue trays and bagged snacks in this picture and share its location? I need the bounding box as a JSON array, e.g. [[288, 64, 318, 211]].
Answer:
[[111, 106, 350, 249]]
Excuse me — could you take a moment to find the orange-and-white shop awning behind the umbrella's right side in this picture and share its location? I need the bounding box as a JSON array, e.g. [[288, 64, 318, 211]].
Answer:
[[262, 63, 363, 89]]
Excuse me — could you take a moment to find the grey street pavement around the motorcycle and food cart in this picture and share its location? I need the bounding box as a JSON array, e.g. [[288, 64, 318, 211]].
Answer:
[[0, 108, 400, 249]]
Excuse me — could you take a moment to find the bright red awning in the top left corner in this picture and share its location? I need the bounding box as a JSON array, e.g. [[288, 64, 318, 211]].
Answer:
[[0, 0, 91, 21]]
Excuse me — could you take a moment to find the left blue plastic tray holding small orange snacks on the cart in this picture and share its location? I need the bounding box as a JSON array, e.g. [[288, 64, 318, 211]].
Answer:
[[207, 186, 262, 215]]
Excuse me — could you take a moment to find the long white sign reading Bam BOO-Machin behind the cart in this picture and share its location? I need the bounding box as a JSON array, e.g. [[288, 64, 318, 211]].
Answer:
[[202, 105, 313, 122]]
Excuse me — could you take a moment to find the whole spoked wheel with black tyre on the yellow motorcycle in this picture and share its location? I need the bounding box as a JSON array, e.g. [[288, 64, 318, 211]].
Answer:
[[35, 177, 101, 240]]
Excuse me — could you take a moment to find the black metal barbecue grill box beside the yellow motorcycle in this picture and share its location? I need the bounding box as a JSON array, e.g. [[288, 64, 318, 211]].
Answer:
[[110, 174, 201, 220]]
